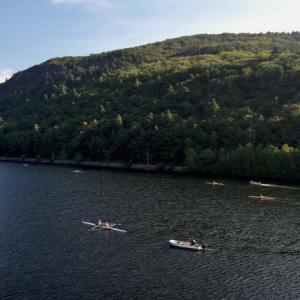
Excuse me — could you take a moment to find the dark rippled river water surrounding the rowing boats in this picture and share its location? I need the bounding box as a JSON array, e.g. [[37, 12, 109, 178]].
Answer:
[[0, 163, 300, 299]]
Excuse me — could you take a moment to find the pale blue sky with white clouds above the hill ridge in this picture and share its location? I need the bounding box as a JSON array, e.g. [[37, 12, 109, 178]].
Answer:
[[0, 0, 300, 82]]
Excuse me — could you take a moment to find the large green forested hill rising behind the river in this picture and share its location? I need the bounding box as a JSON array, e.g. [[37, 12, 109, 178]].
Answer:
[[0, 32, 300, 181]]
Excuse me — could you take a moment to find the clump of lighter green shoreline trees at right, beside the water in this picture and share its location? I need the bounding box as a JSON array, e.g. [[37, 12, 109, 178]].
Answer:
[[185, 143, 300, 182]]
